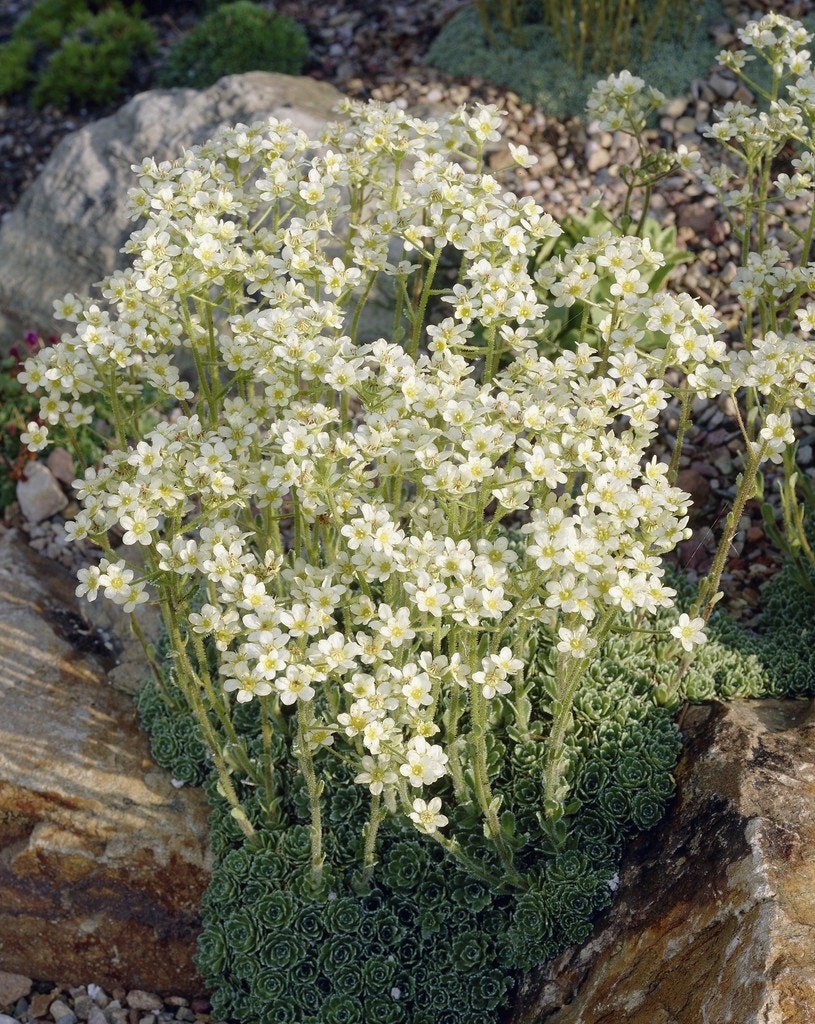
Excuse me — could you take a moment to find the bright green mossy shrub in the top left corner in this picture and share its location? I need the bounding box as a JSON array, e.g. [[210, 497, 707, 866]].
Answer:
[[0, 0, 156, 106]]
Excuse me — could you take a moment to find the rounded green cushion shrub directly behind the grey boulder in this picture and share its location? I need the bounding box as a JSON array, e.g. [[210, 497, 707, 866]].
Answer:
[[159, 0, 308, 89]]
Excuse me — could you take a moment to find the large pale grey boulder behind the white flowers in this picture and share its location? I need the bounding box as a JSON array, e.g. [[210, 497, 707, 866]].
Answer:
[[0, 72, 341, 350]]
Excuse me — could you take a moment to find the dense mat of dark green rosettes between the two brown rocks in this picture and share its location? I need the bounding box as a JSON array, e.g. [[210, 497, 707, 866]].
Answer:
[[138, 610, 680, 1024]]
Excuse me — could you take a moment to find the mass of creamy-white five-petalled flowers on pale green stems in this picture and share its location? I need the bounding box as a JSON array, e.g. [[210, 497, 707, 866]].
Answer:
[[20, 14, 815, 870]]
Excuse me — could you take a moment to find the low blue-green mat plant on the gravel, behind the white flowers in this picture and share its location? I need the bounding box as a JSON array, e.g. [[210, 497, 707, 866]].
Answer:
[[427, 0, 722, 118]]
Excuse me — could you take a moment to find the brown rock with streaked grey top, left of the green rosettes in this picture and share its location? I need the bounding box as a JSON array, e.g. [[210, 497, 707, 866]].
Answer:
[[0, 530, 211, 995]]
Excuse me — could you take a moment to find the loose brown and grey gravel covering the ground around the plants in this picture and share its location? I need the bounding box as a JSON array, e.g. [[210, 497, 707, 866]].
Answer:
[[0, 0, 815, 1024]]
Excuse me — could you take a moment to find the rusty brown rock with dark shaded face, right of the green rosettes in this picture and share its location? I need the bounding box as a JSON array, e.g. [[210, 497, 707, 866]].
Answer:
[[508, 700, 815, 1024]]
